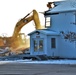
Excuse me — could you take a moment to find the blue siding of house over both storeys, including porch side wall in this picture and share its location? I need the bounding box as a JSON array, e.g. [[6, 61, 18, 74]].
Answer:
[[46, 12, 76, 58]]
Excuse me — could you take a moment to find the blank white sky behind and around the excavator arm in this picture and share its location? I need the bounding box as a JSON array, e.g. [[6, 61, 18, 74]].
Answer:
[[0, 0, 60, 36]]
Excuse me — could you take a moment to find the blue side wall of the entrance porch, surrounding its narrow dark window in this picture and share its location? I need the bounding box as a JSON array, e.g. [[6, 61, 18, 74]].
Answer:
[[47, 35, 59, 57]]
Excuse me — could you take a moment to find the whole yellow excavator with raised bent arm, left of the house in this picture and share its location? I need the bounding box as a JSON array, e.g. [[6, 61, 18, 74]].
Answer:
[[0, 10, 43, 54]]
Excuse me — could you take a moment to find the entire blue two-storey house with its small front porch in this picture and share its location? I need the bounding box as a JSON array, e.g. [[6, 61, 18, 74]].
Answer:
[[29, 0, 76, 58]]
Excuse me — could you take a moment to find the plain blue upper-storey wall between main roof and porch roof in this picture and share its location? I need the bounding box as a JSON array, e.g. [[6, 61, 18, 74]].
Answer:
[[50, 12, 76, 32]]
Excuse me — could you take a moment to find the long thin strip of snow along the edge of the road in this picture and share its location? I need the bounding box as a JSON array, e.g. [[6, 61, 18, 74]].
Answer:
[[0, 60, 76, 65]]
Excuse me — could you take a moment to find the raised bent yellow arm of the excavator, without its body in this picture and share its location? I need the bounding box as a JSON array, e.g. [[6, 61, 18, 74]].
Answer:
[[13, 10, 42, 37]]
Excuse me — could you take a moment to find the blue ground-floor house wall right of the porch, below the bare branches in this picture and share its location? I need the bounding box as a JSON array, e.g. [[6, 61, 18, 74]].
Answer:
[[58, 37, 76, 58]]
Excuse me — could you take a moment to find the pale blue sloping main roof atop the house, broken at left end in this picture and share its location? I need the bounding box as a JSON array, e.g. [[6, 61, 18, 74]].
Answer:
[[47, 0, 76, 13]]
